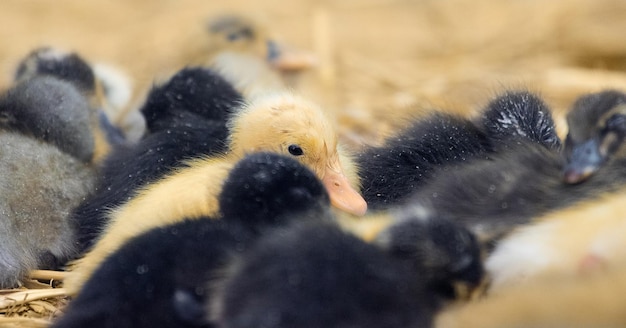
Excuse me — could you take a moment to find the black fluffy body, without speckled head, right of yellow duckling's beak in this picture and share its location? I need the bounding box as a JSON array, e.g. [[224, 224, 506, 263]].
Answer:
[[355, 113, 489, 210]]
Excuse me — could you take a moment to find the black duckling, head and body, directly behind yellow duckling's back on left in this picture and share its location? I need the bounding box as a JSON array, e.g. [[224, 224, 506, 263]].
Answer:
[[73, 68, 243, 251]]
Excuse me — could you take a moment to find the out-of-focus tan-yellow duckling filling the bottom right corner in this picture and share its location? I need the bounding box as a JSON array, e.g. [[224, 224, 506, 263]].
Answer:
[[434, 267, 626, 328]]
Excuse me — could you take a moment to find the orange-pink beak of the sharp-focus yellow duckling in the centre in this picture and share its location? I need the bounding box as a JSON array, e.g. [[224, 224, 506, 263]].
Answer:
[[322, 167, 367, 216]]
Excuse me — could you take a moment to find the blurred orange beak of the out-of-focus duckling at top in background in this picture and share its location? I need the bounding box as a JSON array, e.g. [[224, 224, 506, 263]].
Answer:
[[267, 40, 317, 72]]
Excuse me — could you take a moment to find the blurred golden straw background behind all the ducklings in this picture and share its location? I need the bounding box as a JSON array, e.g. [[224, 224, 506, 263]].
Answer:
[[0, 0, 626, 145]]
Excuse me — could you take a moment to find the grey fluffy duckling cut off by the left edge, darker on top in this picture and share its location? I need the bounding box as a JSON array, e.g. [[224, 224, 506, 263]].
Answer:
[[0, 76, 95, 288]]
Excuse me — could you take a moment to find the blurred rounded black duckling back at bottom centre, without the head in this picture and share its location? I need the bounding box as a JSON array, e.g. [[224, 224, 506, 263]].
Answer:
[[210, 222, 439, 328]]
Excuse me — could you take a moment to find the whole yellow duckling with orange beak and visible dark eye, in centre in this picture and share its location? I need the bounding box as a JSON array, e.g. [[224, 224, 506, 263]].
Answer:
[[65, 93, 367, 293]]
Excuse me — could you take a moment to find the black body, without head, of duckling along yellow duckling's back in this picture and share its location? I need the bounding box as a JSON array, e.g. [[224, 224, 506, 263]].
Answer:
[[72, 124, 225, 251]]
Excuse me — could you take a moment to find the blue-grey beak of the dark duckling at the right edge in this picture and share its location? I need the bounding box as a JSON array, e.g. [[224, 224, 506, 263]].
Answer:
[[563, 139, 606, 184]]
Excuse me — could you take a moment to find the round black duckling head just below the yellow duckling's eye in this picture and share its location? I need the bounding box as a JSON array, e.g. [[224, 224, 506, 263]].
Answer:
[[219, 153, 330, 230]]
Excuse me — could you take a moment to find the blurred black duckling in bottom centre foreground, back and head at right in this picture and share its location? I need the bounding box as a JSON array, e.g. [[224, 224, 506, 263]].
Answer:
[[210, 205, 482, 328]]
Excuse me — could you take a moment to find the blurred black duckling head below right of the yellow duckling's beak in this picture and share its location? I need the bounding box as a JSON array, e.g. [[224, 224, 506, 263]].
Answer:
[[374, 204, 484, 298]]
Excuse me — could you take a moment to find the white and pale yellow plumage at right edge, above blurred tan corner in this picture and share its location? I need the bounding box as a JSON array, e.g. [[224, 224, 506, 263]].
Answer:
[[486, 187, 626, 289]]
